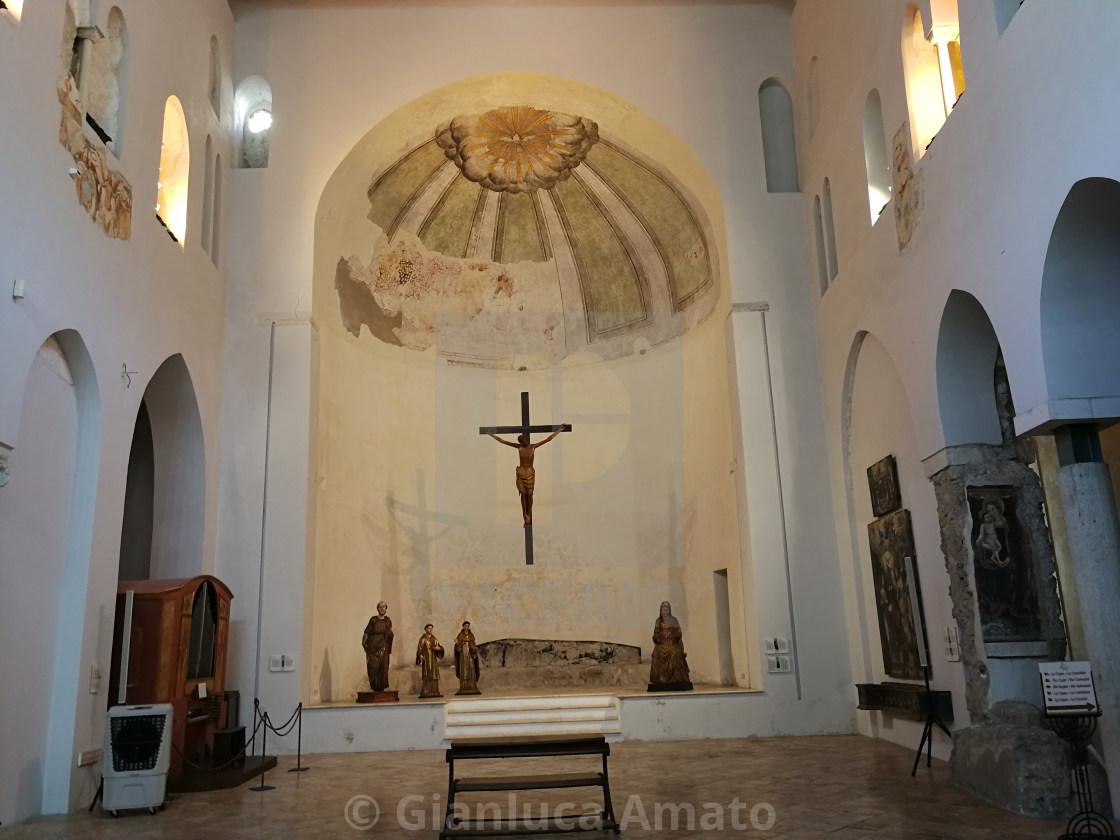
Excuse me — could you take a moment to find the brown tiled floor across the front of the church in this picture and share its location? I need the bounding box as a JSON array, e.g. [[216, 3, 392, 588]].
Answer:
[[10, 736, 1063, 840]]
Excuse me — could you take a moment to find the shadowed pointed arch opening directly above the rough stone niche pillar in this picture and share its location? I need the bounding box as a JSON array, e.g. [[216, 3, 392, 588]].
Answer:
[[936, 289, 1004, 446]]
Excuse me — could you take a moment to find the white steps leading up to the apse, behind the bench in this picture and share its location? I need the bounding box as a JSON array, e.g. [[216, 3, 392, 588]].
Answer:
[[444, 694, 622, 738]]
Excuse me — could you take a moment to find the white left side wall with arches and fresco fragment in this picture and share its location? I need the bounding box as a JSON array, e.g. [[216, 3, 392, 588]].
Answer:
[[0, 0, 233, 823]]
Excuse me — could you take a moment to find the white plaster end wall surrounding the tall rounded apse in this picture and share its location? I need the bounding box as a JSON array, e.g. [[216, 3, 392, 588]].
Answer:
[[218, 3, 852, 748]]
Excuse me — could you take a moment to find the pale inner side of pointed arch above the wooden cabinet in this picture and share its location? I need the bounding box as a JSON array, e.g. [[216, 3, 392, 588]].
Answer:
[[143, 354, 206, 579]]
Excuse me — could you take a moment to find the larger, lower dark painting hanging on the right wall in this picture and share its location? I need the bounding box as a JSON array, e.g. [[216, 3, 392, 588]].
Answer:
[[867, 510, 928, 680]]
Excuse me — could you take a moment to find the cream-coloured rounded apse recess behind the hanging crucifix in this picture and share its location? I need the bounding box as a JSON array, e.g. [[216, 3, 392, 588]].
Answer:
[[302, 73, 748, 701]]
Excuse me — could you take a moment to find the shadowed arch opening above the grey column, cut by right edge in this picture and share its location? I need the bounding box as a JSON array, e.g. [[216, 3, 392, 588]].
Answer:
[[1039, 177, 1120, 401]]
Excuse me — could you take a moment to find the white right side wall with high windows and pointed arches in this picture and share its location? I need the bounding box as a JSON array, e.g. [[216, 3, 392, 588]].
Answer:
[[793, 0, 1120, 761]]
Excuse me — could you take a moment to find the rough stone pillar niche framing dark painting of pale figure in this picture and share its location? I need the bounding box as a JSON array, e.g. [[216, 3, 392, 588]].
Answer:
[[927, 445, 1065, 721]]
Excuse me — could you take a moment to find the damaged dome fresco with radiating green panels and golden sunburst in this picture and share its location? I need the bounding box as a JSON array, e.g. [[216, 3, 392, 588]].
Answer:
[[334, 99, 719, 366]]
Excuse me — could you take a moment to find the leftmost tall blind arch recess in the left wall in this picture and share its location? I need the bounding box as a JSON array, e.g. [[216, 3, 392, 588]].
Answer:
[[0, 329, 101, 822]]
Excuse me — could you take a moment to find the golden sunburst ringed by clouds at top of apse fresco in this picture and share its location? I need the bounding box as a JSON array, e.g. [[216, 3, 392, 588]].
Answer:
[[436, 105, 599, 193]]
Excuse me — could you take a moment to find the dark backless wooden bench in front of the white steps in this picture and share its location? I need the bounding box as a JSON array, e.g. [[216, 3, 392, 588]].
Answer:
[[439, 735, 622, 840]]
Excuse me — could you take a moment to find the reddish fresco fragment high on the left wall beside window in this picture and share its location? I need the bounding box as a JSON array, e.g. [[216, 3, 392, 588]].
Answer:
[[58, 73, 132, 240]]
